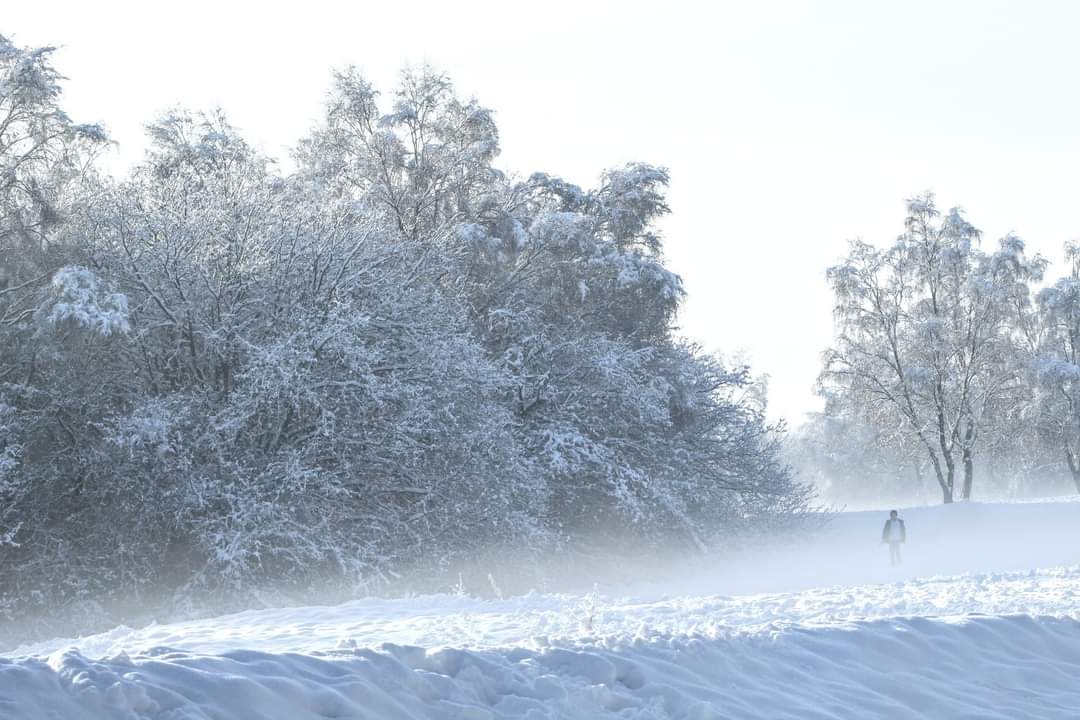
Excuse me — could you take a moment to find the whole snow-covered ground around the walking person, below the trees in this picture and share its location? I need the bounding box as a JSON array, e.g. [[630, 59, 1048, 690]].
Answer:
[[0, 501, 1080, 720]]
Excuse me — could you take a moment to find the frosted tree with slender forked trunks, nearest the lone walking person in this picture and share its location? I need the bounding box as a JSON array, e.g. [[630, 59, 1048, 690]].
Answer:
[[822, 194, 1044, 503]]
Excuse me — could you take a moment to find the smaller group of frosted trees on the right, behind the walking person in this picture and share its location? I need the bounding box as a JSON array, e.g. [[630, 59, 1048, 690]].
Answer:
[[787, 194, 1080, 503]]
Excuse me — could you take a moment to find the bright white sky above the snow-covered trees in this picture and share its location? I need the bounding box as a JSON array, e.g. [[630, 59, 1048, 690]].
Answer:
[[8, 0, 1080, 424]]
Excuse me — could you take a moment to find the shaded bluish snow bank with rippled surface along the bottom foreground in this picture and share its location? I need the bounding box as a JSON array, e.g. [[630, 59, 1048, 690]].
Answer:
[[0, 615, 1080, 720]]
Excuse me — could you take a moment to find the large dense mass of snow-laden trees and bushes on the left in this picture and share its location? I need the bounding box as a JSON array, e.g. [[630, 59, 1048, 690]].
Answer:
[[0, 37, 808, 643]]
